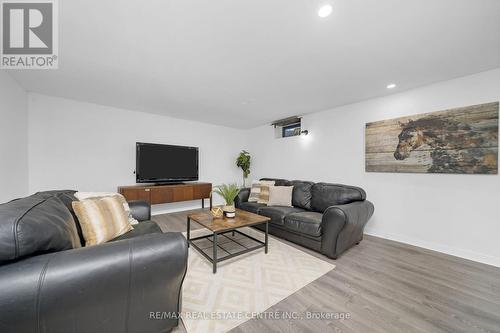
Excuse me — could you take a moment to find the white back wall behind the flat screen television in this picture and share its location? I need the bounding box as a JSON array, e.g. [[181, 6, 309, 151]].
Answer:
[[29, 94, 246, 213]]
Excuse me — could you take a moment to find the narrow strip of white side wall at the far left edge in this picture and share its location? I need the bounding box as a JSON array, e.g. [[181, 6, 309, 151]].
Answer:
[[0, 71, 28, 203]]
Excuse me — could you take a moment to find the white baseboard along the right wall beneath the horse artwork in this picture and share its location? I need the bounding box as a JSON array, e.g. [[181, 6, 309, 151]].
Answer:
[[365, 231, 500, 267]]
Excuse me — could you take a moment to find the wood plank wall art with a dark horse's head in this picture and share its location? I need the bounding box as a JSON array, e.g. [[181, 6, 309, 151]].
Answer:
[[365, 102, 499, 174]]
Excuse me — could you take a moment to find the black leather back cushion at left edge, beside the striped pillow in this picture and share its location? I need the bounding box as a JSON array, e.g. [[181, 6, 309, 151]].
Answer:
[[0, 195, 80, 262]]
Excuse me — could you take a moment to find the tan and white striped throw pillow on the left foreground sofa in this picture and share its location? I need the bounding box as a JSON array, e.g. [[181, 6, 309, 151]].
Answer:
[[72, 196, 133, 246]]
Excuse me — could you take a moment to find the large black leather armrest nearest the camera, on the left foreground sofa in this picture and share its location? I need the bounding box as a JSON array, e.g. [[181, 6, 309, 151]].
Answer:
[[0, 233, 188, 333]]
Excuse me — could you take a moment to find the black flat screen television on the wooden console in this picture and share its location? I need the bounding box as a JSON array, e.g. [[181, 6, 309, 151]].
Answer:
[[135, 142, 198, 183]]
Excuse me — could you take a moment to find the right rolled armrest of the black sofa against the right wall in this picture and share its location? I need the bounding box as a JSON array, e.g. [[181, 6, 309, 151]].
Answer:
[[321, 200, 374, 259]]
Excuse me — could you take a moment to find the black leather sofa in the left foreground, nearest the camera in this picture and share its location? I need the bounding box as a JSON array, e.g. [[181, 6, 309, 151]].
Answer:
[[0, 191, 188, 333]]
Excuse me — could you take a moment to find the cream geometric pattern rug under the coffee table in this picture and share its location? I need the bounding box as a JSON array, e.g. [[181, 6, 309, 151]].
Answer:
[[178, 228, 335, 333]]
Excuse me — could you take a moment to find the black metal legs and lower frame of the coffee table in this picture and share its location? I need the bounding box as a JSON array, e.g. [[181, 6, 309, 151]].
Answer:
[[187, 219, 269, 274]]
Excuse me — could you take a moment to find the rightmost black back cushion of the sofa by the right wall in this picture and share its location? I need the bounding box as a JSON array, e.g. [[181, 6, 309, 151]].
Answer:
[[311, 183, 366, 213]]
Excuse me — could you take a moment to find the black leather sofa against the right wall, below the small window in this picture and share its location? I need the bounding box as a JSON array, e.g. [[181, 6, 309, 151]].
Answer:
[[235, 178, 374, 259]]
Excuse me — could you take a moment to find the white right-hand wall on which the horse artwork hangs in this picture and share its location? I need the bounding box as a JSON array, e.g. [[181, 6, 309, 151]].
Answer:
[[248, 69, 500, 266]]
